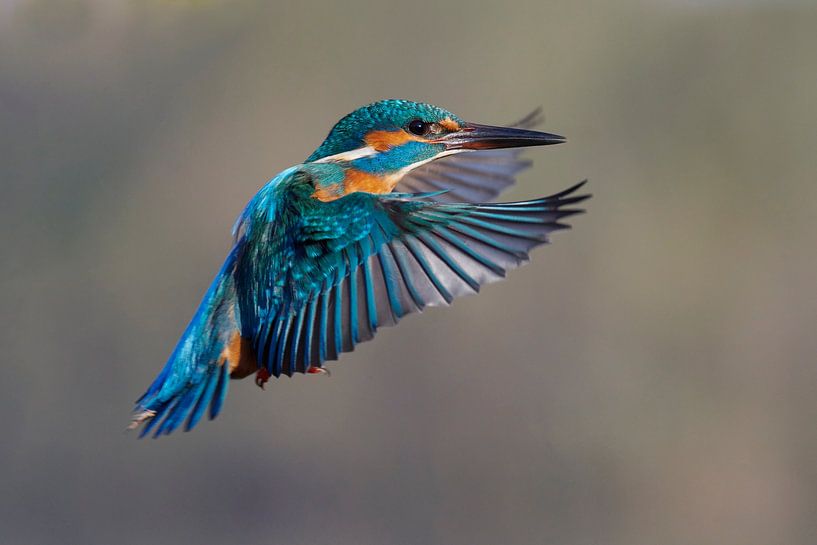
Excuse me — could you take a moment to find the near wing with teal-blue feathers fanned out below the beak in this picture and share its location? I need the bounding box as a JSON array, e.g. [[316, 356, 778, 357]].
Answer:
[[242, 178, 589, 376]]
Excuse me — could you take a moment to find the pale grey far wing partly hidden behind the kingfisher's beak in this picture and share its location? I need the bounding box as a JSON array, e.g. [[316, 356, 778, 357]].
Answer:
[[395, 108, 542, 202]]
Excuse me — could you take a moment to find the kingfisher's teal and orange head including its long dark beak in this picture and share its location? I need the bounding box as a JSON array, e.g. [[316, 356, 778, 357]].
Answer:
[[307, 99, 565, 200]]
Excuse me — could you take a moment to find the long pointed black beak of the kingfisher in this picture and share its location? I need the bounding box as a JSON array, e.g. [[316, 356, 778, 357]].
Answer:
[[438, 123, 567, 150]]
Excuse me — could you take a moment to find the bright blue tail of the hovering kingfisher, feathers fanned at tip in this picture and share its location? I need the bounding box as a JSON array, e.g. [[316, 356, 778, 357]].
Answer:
[[128, 248, 240, 438]]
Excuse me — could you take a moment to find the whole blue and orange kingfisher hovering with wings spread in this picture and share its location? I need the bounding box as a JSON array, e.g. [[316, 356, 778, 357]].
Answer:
[[129, 100, 590, 437]]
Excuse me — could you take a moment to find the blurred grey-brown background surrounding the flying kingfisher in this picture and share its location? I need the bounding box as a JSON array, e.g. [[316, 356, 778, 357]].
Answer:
[[0, 0, 817, 545]]
